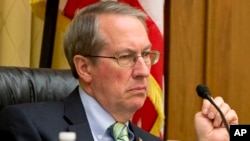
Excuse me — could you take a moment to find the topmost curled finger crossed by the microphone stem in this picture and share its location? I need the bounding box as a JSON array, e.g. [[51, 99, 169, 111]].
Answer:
[[207, 97, 224, 120]]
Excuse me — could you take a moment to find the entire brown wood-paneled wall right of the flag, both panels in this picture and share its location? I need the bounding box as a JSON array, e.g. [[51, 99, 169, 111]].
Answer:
[[166, 0, 250, 141]]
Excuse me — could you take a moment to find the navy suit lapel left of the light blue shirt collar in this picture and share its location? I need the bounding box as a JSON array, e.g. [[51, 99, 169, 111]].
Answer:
[[64, 87, 94, 141]]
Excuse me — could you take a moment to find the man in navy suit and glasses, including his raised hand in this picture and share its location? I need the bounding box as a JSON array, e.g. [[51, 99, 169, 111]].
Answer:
[[0, 1, 238, 141]]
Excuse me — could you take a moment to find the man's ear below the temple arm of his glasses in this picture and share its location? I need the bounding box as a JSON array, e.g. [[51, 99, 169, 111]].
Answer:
[[73, 55, 91, 83]]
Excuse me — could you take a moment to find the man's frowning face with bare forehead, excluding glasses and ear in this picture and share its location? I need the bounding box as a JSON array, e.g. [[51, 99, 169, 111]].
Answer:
[[87, 15, 151, 118]]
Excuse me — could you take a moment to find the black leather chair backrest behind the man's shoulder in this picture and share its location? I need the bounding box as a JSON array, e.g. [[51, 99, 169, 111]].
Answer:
[[0, 66, 79, 111]]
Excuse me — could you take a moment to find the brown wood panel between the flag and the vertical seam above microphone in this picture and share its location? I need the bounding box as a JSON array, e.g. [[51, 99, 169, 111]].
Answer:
[[166, 0, 205, 141]]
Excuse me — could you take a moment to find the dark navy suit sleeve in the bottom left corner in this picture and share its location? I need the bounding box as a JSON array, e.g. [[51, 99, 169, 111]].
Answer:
[[0, 106, 42, 141]]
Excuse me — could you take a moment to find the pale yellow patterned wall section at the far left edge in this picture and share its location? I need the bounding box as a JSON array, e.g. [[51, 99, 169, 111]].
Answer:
[[0, 0, 32, 66]]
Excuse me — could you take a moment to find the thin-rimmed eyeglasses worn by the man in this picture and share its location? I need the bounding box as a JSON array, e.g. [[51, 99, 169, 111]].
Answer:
[[83, 51, 160, 68]]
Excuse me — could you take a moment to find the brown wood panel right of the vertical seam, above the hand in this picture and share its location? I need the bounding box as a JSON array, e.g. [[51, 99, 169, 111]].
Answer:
[[206, 0, 250, 124]]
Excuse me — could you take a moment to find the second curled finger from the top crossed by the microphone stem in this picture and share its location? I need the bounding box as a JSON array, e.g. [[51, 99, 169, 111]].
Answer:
[[213, 103, 231, 127]]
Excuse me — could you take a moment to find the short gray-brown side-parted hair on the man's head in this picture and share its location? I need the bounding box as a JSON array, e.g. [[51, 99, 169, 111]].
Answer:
[[63, 1, 147, 78]]
